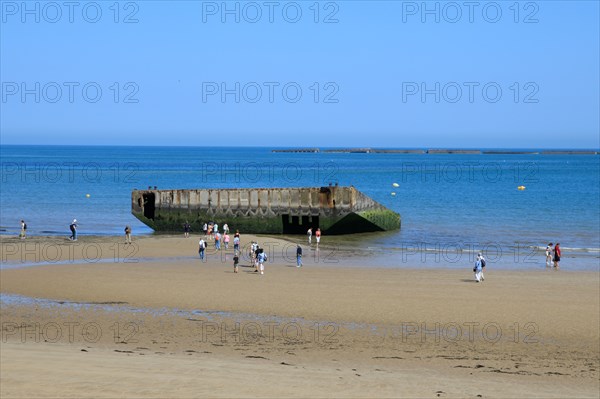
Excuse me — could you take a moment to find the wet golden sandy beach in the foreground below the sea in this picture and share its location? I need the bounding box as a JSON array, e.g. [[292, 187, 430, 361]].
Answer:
[[0, 235, 600, 398]]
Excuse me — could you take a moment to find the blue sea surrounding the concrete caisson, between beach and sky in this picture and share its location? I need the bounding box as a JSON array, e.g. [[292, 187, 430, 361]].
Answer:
[[0, 145, 600, 271]]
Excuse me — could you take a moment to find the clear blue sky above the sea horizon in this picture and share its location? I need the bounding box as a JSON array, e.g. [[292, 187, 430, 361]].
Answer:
[[0, 0, 600, 148]]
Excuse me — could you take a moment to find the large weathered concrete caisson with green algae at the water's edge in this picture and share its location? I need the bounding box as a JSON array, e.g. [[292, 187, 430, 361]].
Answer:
[[131, 186, 400, 234]]
